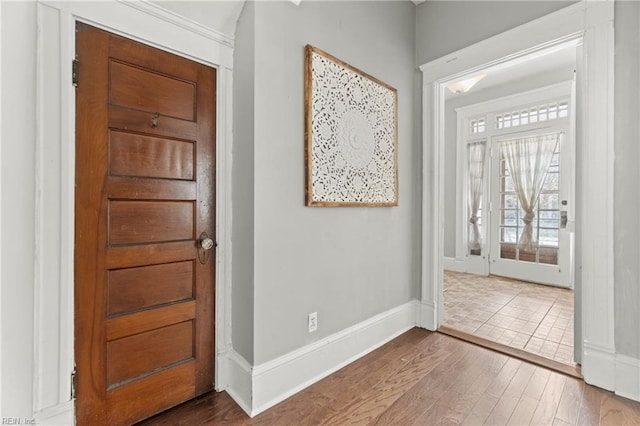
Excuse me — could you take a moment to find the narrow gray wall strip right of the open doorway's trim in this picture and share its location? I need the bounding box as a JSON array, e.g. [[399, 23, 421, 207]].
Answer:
[[614, 2, 640, 359]]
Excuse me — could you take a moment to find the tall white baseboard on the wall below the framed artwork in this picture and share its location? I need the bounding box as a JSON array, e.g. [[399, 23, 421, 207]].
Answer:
[[244, 300, 418, 417]]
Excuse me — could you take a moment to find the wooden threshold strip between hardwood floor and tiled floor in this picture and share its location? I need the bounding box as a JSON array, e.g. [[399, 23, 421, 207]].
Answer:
[[437, 326, 583, 380]]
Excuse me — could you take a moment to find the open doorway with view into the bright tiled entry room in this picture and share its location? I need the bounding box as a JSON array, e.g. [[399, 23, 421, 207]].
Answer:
[[439, 37, 581, 375]]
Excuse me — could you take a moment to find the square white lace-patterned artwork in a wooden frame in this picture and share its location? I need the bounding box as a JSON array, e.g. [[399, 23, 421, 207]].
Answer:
[[304, 45, 398, 206]]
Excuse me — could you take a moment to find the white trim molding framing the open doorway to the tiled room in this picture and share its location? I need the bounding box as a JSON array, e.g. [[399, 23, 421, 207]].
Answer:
[[420, 0, 615, 398]]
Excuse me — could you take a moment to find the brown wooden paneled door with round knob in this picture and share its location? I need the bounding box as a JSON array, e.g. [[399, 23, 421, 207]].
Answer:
[[75, 24, 216, 425]]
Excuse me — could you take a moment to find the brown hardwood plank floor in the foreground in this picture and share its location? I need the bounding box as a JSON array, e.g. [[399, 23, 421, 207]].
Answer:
[[140, 328, 640, 426]]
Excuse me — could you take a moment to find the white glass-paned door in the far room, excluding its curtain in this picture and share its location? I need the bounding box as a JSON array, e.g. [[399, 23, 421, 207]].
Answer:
[[489, 126, 573, 287]]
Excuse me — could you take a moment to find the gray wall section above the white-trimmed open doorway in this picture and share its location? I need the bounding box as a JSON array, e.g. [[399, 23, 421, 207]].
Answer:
[[416, 0, 573, 65]]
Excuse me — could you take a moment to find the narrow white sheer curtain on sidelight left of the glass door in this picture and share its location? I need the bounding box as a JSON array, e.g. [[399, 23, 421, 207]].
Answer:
[[467, 141, 487, 250]]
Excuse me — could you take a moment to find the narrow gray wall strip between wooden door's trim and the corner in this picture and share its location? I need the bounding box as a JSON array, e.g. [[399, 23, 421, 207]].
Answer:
[[231, 2, 255, 363]]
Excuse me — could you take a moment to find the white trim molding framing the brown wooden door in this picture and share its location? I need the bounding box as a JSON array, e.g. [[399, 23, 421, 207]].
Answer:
[[33, 0, 234, 424]]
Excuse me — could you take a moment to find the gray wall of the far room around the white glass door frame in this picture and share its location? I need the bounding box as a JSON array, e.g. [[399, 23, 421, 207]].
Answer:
[[444, 68, 574, 257]]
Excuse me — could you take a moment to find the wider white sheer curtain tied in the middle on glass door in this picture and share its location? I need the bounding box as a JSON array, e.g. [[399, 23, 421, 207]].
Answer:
[[502, 133, 560, 251]]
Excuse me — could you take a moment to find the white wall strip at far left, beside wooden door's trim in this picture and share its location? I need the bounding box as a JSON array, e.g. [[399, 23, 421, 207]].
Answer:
[[0, 2, 36, 416]]
